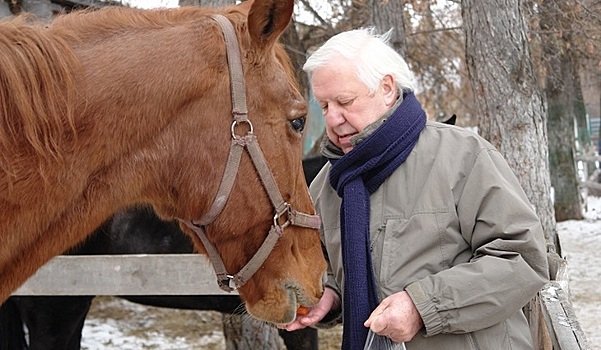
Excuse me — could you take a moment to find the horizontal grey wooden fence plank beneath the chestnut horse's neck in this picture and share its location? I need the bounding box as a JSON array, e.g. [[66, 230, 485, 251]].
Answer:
[[14, 254, 236, 295]]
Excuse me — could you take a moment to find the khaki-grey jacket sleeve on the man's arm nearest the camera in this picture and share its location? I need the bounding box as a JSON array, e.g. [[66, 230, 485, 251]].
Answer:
[[406, 149, 548, 336]]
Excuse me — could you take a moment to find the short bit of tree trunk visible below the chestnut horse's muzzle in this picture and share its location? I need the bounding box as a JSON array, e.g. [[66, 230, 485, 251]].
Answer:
[[223, 314, 283, 350]]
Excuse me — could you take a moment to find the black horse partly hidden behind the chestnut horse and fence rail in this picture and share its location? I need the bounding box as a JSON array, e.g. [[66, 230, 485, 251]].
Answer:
[[0, 156, 326, 350]]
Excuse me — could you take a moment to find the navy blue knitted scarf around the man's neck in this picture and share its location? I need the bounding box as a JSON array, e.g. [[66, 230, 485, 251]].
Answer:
[[329, 93, 426, 350]]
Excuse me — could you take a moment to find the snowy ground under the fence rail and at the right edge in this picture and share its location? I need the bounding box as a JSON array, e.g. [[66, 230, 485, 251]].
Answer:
[[82, 197, 601, 350]]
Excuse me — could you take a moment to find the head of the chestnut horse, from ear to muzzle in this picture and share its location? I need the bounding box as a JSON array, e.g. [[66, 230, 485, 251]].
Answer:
[[137, 1, 325, 323]]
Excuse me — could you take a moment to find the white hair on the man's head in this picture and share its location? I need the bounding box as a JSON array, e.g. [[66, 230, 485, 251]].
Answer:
[[303, 27, 414, 92]]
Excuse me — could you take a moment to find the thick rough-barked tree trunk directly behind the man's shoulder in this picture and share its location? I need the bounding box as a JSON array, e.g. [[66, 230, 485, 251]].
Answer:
[[461, 0, 559, 250]]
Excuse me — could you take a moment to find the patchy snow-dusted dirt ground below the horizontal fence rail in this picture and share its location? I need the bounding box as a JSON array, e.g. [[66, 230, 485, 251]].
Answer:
[[82, 297, 342, 350]]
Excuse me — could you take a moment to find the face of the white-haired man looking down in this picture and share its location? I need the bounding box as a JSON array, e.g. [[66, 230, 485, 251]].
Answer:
[[311, 57, 397, 153]]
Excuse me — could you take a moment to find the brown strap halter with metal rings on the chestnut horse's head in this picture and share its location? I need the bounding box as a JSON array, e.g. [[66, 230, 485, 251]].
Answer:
[[181, 15, 320, 292]]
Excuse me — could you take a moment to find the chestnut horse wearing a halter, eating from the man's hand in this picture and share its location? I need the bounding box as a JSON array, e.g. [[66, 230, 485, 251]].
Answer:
[[0, 0, 325, 324]]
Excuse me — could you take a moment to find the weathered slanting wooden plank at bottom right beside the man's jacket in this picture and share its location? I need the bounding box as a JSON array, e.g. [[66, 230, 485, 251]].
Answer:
[[539, 281, 590, 350]]
